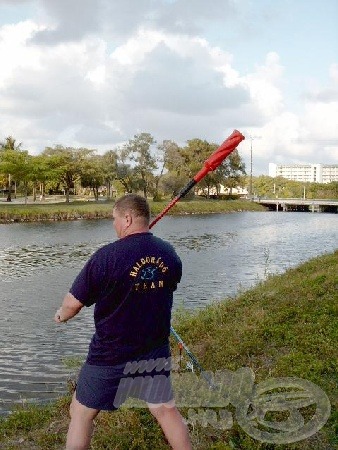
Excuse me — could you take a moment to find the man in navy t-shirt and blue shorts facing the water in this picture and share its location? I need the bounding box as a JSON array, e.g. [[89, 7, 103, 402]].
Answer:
[[54, 194, 192, 450]]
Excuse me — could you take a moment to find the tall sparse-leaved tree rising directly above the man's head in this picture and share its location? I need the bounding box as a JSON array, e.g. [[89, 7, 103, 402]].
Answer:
[[125, 133, 157, 198]]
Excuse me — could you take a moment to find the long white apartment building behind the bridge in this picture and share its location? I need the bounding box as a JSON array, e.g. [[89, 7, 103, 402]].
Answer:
[[269, 163, 338, 183]]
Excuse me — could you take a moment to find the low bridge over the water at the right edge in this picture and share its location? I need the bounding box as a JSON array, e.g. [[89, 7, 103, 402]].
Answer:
[[253, 198, 338, 214]]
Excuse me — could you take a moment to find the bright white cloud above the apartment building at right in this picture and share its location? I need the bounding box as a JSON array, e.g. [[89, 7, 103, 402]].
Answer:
[[238, 54, 338, 173]]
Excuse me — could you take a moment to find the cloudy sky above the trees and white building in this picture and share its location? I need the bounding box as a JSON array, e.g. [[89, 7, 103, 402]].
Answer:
[[0, 0, 338, 175]]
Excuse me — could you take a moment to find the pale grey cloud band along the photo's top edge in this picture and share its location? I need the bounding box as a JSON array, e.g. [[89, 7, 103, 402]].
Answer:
[[27, 0, 244, 45]]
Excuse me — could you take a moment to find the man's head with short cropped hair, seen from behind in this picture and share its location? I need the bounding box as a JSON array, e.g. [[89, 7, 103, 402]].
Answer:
[[113, 194, 150, 238]]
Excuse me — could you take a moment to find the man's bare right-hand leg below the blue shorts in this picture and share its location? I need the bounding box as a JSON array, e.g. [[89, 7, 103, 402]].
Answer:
[[148, 402, 192, 450]]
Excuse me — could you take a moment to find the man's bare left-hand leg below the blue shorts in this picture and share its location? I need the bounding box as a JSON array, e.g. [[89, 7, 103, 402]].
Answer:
[[66, 393, 100, 450]]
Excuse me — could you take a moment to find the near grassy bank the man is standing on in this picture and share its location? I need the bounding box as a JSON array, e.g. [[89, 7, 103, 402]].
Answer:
[[0, 251, 338, 450]]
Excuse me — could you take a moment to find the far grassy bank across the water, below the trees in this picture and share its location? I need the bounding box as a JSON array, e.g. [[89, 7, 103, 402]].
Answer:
[[0, 200, 265, 223]]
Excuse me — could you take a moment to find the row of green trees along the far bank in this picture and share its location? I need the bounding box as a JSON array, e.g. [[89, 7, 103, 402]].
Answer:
[[0, 133, 246, 202]]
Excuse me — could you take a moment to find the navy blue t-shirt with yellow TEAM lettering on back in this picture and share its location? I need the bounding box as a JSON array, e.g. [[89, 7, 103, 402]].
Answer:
[[70, 232, 182, 365]]
